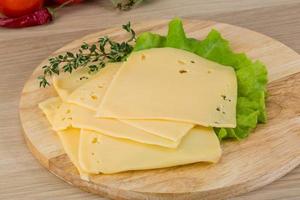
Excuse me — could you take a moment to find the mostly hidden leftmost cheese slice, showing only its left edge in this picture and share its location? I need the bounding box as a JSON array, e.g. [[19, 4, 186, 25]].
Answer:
[[39, 97, 89, 180]]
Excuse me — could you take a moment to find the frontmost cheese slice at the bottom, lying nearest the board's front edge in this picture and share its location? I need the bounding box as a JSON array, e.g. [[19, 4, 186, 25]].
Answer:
[[79, 127, 222, 174]]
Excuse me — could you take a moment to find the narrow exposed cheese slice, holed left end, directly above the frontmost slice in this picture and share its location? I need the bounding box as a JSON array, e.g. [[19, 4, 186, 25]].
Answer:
[[53, 102, 180, 148]]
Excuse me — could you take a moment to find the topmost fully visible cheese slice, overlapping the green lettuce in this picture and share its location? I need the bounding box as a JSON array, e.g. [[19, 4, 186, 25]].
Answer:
[[97, 48, 237, 127]]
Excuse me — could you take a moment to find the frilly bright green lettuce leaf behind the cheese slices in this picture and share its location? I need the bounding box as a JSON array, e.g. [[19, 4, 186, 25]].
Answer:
[[134, 19, 268, 140]]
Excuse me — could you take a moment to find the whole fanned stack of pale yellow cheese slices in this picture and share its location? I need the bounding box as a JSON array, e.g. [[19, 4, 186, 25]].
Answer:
[[39, 48, 237, 178]]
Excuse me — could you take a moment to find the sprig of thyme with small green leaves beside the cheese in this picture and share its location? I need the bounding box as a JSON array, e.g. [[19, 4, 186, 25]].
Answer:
[[38, 22, 136, 87]]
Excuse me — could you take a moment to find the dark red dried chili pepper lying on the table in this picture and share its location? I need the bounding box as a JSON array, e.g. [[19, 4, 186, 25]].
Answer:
[[0, 8, 53, 28]]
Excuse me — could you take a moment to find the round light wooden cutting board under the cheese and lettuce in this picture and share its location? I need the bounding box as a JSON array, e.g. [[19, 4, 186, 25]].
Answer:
[[20, 20, 300, 200]]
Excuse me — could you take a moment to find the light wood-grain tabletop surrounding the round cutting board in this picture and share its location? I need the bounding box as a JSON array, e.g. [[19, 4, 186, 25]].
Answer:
[[0, 0, 300, 200]]
